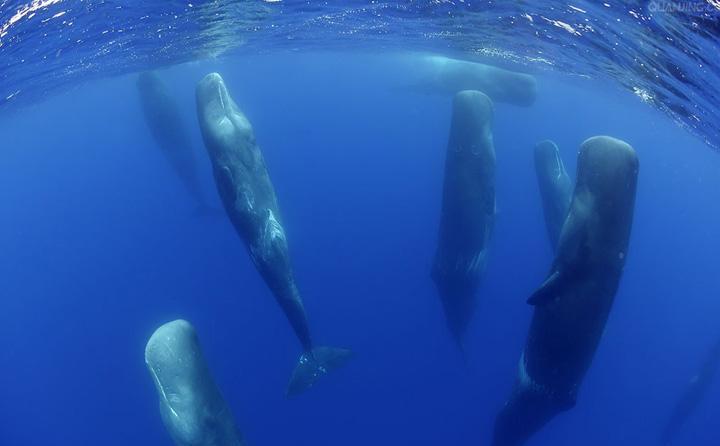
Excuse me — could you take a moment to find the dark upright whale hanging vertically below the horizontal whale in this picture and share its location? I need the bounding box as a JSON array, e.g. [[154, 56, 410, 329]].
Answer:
[[432, 90, 495, 348]]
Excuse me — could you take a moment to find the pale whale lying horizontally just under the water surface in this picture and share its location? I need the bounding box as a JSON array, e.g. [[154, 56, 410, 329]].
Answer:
[[405, 55, 537, 107]]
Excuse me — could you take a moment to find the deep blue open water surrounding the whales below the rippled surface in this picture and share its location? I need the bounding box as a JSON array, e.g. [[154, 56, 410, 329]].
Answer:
[[0, 54, 720, 446]]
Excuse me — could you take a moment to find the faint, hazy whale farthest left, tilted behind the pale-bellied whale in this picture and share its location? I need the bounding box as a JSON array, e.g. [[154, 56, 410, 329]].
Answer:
[[137, 72, 213, 214]]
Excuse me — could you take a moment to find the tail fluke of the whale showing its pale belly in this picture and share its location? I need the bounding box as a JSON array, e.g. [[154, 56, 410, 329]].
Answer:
[[286, 347, 352, 397]]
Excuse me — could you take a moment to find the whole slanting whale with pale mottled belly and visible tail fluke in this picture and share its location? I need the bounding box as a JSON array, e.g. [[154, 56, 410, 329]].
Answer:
[[196, 73, 351, 396]]
